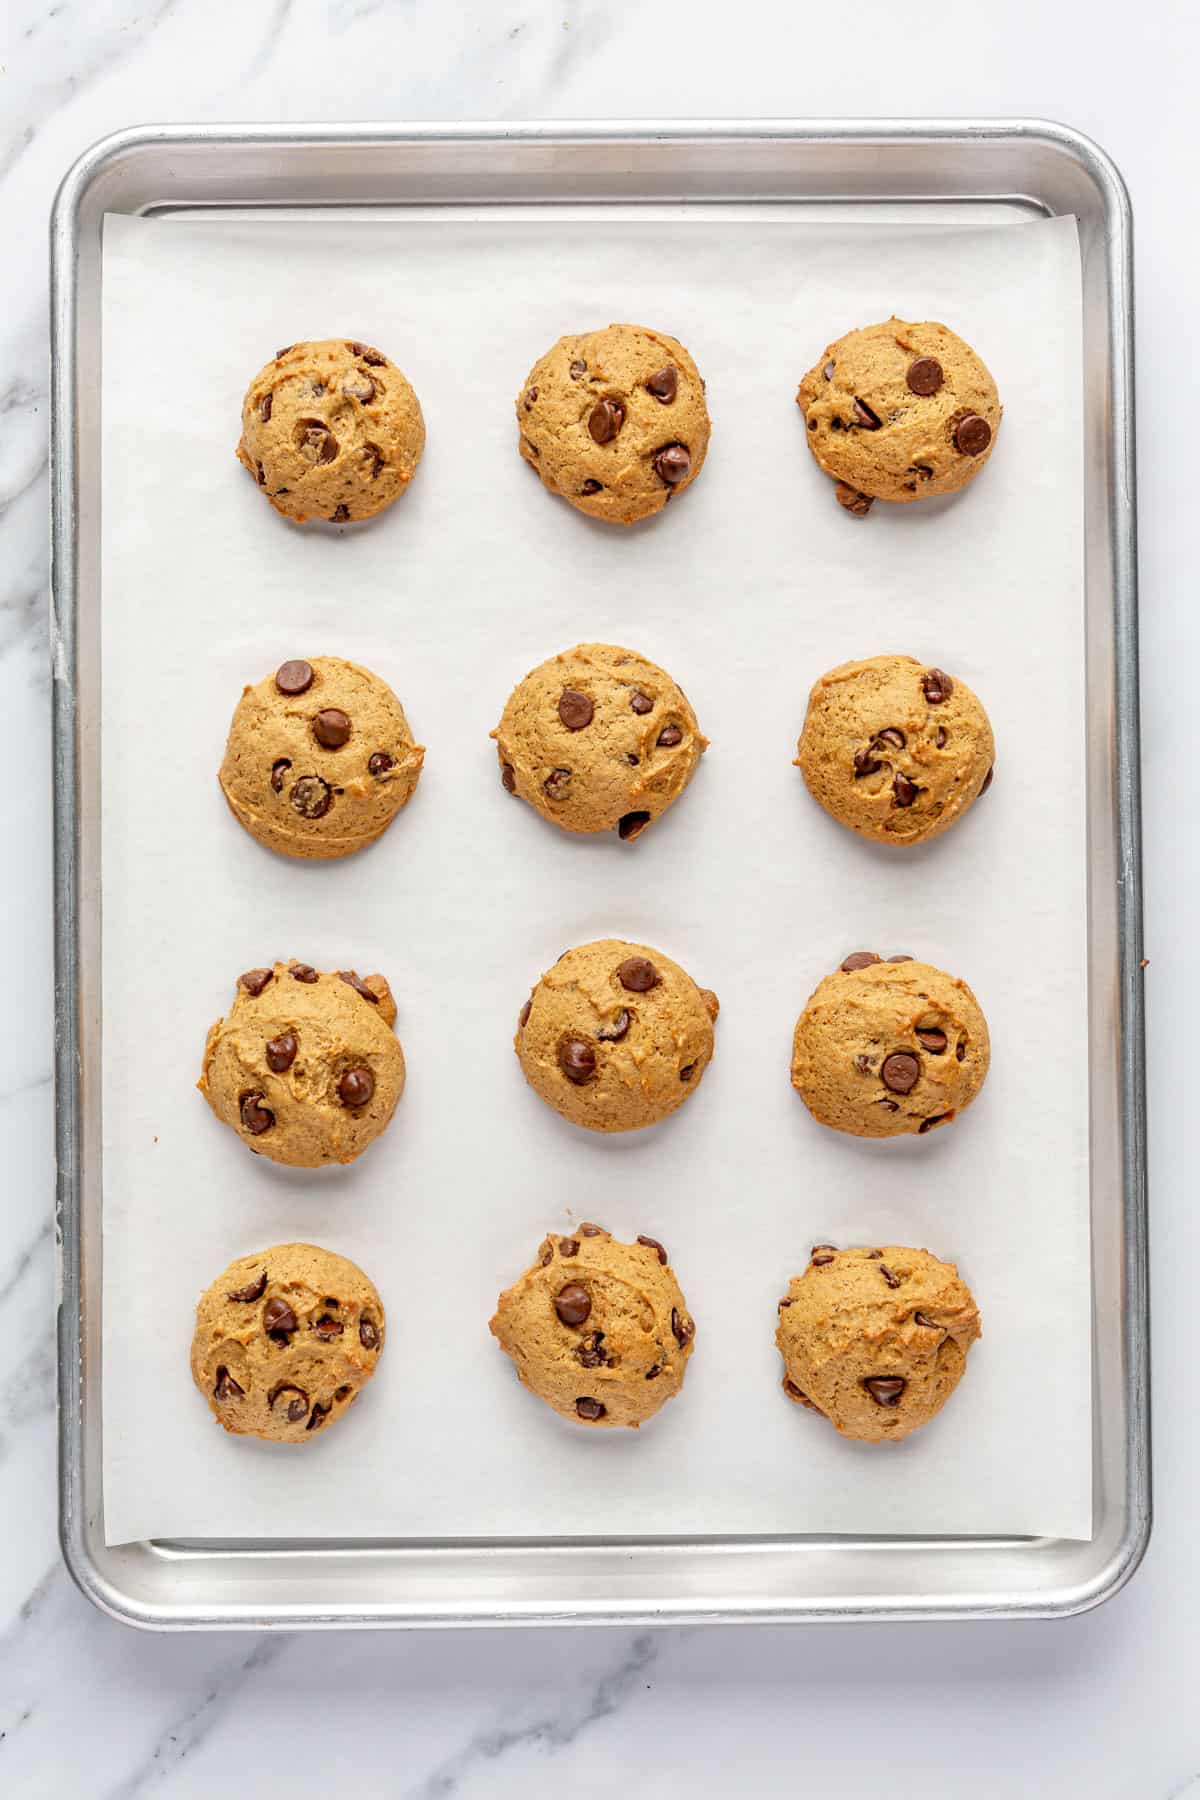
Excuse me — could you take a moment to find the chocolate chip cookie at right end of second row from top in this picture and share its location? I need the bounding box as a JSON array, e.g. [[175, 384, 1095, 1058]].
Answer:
[[795, 657, 995, 844]]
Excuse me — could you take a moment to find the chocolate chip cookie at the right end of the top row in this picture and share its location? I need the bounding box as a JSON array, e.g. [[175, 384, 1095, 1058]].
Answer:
[[795, 319, 1004, 515]]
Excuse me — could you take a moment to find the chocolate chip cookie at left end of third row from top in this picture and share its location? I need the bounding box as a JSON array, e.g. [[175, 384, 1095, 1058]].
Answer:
[[196, 963, 405, 1168]]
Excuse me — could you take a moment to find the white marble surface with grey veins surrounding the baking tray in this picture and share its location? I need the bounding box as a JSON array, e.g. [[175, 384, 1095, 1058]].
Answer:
[[0, 0, 1200, 1800]]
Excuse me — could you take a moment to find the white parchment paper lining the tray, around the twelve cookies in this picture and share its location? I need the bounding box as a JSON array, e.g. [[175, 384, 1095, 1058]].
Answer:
[[103, 214, 1092, 1543]]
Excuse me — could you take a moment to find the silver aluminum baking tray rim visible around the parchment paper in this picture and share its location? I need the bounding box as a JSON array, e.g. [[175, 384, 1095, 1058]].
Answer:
[[50, 121, 1151, 1631]]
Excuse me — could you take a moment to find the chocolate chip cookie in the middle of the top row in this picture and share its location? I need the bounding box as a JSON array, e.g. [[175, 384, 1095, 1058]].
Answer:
[[516, 326, 709, 526]]
